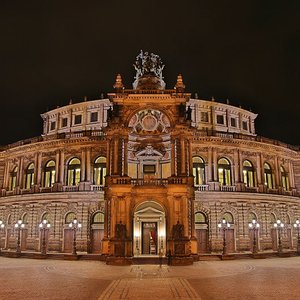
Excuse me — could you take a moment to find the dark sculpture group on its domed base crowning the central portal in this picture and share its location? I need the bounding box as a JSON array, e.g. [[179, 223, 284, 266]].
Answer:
[[133, 50, 166, 90]]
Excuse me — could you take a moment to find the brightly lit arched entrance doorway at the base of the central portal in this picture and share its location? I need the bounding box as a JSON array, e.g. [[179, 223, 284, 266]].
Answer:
[[133, 201, 166, 256]]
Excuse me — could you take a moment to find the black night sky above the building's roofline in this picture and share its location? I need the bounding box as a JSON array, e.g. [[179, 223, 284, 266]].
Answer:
[[0, 0, 300, 145]]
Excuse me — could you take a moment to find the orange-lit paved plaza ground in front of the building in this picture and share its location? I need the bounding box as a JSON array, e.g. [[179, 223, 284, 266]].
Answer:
[[0, 257, 300, 300]]
